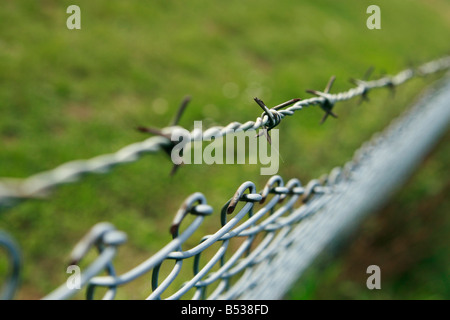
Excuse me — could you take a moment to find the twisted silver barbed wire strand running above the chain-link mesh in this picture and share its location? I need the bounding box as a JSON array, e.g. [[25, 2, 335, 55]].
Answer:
[[0, 56, 450, 208]]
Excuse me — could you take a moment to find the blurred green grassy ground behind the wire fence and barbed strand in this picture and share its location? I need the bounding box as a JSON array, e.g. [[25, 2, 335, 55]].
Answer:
[[0, 0, 450, 299]]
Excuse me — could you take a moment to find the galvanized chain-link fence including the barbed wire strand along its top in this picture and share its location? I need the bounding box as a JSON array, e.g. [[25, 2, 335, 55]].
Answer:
[[0, 58, 450, 299]]
